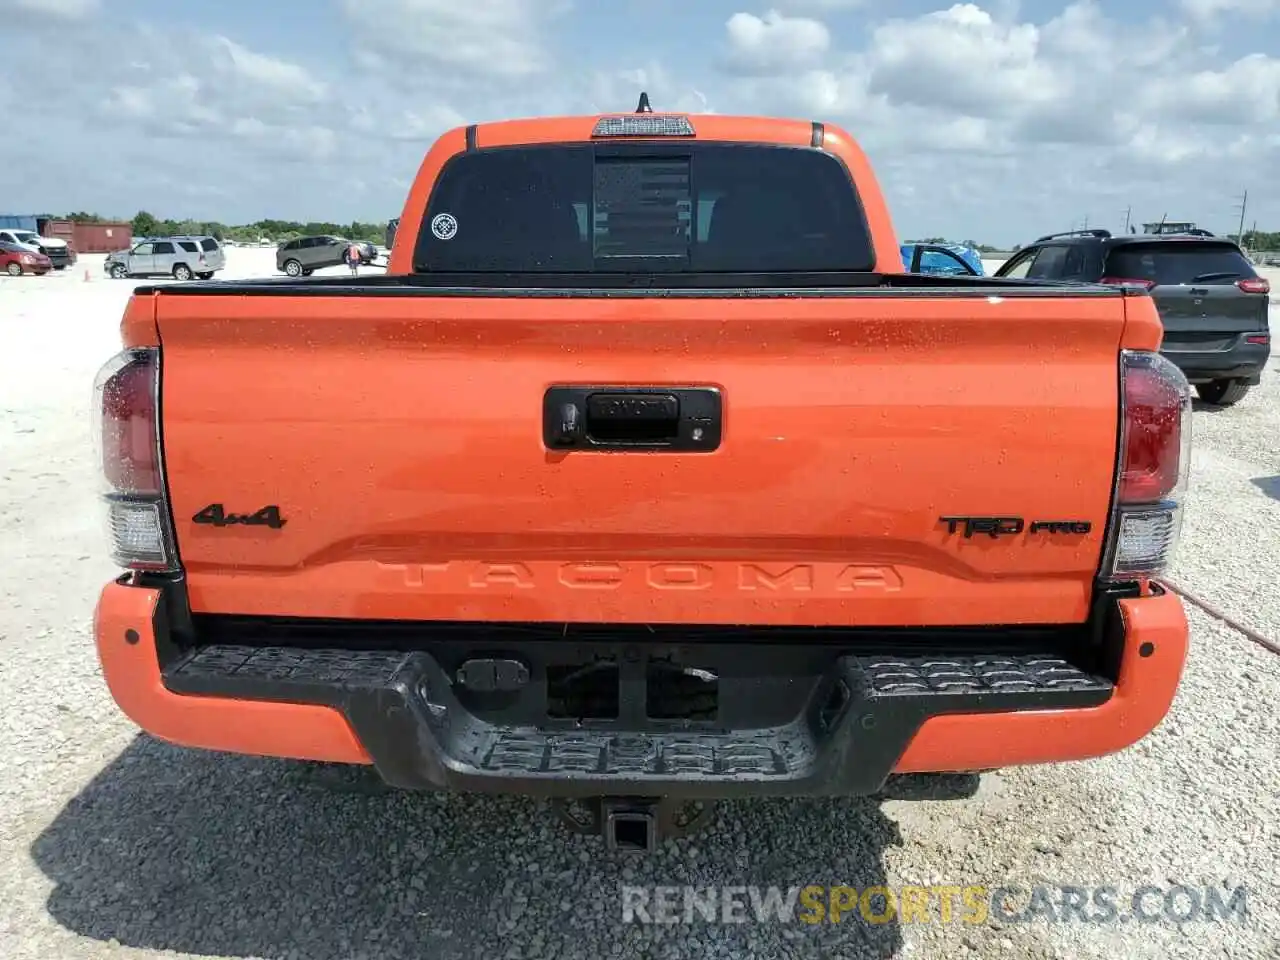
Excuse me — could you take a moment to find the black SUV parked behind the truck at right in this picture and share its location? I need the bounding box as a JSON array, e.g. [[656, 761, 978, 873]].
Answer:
[[996, 230, 1271, 406]]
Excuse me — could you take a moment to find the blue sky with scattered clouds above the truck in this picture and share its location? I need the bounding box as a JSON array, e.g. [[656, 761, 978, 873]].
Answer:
[[0, 0, 1280, 246]]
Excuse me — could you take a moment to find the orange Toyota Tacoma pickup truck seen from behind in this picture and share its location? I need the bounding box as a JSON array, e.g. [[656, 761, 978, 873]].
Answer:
[[96, 101, 1190, 849]]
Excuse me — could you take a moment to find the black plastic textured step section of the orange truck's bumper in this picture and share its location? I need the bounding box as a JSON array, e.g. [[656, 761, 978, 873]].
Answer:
[[164, 645, 1112, 796]]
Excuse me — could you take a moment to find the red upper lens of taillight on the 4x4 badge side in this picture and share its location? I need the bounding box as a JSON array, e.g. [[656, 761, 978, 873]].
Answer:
[[96, 351, 164, 497]]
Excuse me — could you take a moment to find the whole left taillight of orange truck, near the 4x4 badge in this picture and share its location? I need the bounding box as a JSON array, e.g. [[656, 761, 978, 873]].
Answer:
[[93, 348, 178, 571]]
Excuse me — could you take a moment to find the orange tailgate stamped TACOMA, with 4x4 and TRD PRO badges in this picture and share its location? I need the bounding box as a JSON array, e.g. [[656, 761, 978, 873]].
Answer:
[[152, 288, 1125, 626]]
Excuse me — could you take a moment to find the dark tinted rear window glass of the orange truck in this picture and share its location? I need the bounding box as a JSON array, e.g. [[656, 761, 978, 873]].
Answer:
[[415, 143, 874, 273]]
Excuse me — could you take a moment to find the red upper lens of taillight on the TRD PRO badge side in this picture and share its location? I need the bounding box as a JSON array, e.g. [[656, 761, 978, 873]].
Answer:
[[1117, 353, 1190, 503]]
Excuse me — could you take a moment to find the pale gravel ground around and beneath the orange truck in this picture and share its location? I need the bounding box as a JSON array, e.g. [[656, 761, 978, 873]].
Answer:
[[0, 251, 1280, 960]]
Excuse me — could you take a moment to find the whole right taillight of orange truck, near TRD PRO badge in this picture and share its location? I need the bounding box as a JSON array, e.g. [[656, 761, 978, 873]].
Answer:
[[1102, 351, 1192, 581]]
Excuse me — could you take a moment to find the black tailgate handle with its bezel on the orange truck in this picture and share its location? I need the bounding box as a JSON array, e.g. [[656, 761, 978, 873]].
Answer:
[[543, 385, 721, 452]]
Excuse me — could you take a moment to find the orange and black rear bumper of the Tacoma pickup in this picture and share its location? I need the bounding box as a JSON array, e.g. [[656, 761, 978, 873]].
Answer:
[[95, 581, 1188, 799]]
